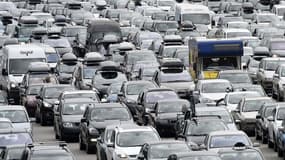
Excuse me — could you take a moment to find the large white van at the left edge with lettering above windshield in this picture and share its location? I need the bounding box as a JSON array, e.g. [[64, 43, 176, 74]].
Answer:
[[0, 44, 47, 104]]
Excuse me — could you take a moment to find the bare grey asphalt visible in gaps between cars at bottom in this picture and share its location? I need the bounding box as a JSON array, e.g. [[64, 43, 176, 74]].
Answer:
[[33, 123, 282, 160]]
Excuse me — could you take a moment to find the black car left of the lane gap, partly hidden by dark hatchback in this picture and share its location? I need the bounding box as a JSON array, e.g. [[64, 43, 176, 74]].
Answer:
[[35, 84, 75, 125]]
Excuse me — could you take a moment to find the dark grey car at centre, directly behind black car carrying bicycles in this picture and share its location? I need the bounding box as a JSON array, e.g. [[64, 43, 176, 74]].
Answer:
[[135, 88, 179, 124]]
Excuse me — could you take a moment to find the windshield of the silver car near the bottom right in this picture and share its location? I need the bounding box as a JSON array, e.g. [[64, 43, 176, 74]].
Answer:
[[210, 135, 250, 148]]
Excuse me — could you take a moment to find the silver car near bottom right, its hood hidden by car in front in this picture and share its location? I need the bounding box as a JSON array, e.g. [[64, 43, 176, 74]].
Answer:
[[205, 131, 254, 151]]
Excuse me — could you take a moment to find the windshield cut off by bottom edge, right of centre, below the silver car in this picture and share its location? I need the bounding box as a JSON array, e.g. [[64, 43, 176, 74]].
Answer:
[[220, 151, 263, 160]]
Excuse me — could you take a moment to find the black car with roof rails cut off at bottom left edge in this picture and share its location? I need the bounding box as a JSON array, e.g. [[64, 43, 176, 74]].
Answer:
[[21, 143, 75, 160]]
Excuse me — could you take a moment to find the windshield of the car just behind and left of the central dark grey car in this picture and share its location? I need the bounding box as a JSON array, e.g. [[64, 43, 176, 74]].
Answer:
[[127, 83, 155, 95]]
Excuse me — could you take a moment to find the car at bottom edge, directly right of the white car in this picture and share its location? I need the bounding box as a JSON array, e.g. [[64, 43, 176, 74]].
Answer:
[[137, 141, 191, 160]]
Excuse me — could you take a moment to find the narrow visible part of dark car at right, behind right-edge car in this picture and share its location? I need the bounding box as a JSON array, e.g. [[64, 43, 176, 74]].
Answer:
[[255, 103, 276, 144]]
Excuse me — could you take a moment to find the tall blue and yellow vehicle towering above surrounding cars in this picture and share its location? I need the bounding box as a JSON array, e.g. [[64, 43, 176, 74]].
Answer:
[[188, 38, 243, 79]]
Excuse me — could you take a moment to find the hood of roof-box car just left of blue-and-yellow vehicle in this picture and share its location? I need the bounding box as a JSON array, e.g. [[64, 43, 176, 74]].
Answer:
[[161, 82, 195, 91]]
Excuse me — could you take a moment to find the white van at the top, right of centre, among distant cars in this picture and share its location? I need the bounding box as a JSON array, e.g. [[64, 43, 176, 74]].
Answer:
[[175, 3, 214, 29]]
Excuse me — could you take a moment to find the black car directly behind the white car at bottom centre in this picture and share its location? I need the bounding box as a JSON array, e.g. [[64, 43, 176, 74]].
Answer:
[[79, 103, 133, 153]]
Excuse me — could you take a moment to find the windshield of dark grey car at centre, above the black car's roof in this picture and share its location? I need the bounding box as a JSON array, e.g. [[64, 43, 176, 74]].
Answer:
[[145, 91, 178, 104]]
